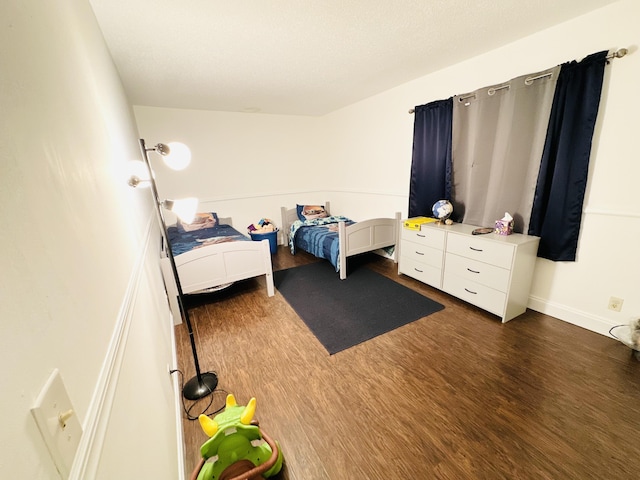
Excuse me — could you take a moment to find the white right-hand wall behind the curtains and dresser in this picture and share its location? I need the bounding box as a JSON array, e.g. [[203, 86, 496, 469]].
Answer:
[[323, 0, 640, 333]]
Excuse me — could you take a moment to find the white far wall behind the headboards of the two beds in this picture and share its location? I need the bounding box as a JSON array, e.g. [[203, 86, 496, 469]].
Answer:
[[134, 106, 331, 238]]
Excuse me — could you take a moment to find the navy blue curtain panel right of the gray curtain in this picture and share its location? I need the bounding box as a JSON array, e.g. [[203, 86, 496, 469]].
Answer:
[[528, 51, 608, 261]]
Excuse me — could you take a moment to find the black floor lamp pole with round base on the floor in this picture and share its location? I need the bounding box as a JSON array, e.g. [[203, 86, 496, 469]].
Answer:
[[140, 138, 218, 400]]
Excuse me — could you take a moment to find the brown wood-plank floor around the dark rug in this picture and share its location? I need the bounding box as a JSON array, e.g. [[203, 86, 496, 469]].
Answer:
[[176, 246, 640, 480]]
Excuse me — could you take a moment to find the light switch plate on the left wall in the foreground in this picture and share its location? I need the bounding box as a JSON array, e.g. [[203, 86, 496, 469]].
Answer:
[[31, 369, 82, 479]]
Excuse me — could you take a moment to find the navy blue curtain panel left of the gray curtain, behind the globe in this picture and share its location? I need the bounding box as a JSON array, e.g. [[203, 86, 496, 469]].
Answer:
[[409, 98, 453, 217]]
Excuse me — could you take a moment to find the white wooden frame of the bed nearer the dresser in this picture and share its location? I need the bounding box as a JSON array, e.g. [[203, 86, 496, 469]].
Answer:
[[280, 202, 402, 280]]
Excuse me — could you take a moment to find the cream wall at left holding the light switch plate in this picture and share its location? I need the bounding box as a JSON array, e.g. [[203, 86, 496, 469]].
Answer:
[[0, 0, 181, 479]]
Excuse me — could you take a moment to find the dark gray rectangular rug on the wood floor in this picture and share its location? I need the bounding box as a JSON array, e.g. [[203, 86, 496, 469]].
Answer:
[[274, 262, 444, 355]]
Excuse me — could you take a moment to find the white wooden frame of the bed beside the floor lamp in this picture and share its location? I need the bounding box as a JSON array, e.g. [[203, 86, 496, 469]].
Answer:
[[160, 217, 275, 323]]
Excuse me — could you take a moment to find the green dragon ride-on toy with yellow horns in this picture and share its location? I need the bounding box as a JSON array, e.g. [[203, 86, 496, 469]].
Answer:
[[191, 394, 283, 480]]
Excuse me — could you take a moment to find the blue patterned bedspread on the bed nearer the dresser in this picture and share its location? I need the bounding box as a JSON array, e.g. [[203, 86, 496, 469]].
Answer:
[[289, 215, 355, 272]]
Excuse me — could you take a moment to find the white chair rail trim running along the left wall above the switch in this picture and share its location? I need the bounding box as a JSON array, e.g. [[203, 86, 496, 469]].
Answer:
[[69, 217, 154, 480]]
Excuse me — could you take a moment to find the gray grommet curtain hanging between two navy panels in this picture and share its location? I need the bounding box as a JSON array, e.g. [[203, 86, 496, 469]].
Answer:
[[452, 66, 560, 233]]
